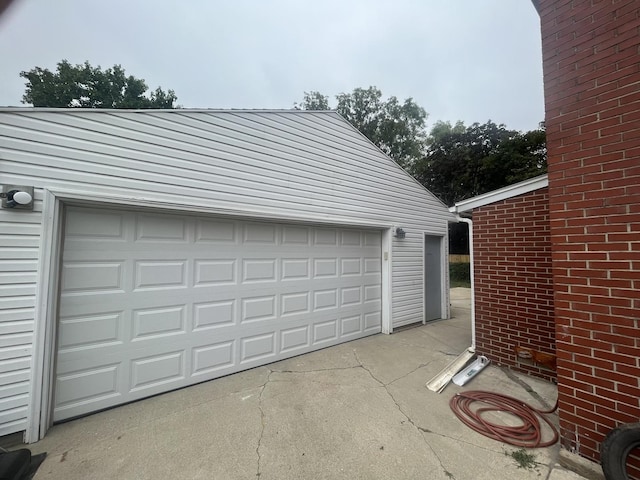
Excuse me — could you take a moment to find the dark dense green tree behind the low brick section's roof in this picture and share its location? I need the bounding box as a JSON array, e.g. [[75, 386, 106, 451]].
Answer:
[[411, 121, 547, 205]]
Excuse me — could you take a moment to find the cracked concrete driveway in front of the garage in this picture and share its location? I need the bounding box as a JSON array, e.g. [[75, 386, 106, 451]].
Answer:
[[29, 289, 596, 480]]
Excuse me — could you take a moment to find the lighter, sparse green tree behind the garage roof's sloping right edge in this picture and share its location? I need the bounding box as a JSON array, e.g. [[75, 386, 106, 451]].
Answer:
[[296, 87, 427, 168]]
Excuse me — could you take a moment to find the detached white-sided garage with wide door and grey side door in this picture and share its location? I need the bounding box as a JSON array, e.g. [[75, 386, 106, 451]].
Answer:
[[0, 109, 452, 442]]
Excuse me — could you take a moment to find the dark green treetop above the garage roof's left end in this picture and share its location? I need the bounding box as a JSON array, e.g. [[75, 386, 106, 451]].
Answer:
[[20, 60, 177, 108]]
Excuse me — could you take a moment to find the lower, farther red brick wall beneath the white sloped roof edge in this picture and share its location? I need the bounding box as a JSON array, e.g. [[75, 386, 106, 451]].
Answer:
[[473, 188, 555, 380]]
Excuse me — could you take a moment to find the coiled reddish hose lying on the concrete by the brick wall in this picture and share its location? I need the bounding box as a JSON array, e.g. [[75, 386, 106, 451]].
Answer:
[[449, 390, 558, 448]]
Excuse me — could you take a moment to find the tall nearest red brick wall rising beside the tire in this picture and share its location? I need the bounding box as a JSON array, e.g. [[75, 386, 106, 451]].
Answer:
[[540, 0, 640, 466]]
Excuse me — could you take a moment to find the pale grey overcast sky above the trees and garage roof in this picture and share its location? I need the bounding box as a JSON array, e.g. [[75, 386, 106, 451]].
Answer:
[[0, 0, 544, 130]]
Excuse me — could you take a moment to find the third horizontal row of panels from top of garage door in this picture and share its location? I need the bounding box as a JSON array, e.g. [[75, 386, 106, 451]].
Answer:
[[60, 294, 381, 340]]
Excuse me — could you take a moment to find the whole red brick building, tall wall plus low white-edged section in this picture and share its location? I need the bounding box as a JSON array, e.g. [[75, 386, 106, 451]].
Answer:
[[457, 0, 640, 470]]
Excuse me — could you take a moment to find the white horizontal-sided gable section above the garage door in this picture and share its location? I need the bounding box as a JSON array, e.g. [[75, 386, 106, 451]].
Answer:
[[1, 112, 448, 227]]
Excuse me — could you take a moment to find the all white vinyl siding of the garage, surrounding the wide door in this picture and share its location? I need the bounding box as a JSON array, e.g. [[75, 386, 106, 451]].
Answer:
[[0, 109, 452, 434]]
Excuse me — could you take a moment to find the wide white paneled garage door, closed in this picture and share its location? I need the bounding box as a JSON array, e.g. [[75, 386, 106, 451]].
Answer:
[[54, 207, 381, 421]]
